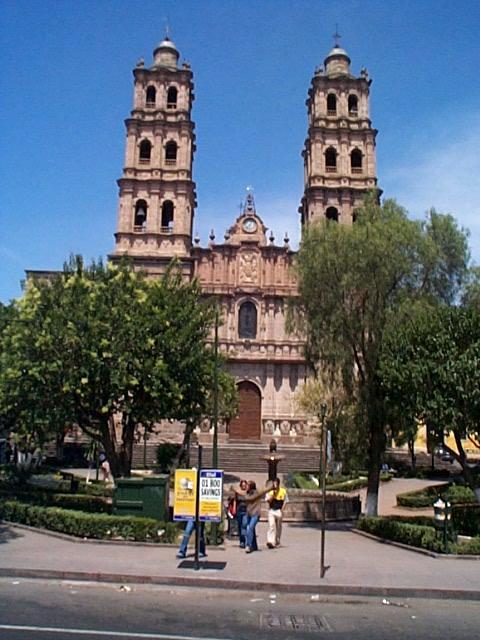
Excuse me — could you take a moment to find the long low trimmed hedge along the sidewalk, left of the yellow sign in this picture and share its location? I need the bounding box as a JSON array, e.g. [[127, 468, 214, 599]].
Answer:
[[0, 500, 179, 543]]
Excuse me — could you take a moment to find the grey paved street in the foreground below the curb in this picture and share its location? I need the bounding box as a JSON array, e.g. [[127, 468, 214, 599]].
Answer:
[[0, 579, 479, 640]]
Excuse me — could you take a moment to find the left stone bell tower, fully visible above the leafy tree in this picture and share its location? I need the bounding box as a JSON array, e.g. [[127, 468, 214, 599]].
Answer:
[[111, 37, 196, 271]]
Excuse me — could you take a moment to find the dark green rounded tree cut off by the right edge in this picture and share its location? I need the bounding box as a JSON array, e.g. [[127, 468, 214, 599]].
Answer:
[[380, 306, 480, 502]]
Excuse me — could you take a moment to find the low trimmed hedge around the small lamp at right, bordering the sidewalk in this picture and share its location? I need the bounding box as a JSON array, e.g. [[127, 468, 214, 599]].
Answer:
[[357, 516, 480, 555]]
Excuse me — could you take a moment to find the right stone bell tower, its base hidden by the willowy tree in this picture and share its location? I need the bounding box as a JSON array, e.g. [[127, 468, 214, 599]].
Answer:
[[299, 34, 377, 228]]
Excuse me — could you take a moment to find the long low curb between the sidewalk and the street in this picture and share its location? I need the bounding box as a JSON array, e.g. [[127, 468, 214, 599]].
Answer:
[[0, 567, 480, 601]]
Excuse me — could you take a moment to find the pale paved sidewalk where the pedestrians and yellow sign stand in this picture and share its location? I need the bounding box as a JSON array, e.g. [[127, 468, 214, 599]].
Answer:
[[0, 523, 480, 600]]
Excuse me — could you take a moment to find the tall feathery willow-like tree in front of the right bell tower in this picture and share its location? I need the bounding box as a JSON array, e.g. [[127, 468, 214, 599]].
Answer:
[[290, 194, 469, 515]]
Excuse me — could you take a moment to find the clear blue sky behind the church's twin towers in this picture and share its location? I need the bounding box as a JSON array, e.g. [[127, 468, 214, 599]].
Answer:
[[0, 0, 480, 302]]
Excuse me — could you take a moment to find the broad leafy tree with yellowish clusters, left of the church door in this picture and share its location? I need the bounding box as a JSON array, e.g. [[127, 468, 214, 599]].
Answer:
[[0, 257, 221, 477]]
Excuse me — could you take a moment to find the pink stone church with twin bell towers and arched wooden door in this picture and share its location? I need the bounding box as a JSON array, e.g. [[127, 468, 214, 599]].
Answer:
[[110, 38, 377, 445]]
